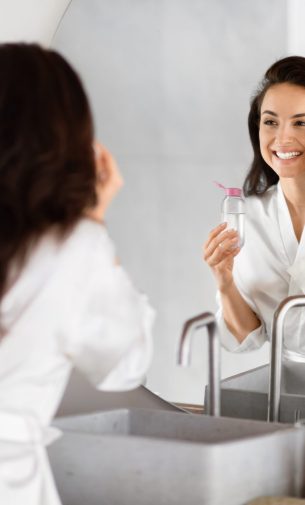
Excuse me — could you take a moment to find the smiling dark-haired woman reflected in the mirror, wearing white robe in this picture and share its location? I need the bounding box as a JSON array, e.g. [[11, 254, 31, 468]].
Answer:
[[204, 56, 305, 359]]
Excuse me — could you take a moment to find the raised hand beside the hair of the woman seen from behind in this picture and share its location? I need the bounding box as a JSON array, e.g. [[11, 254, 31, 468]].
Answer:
[[85, 142, 123, 222]]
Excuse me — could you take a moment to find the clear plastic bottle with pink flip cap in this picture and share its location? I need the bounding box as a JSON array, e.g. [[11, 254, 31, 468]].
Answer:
[[216, 183, 246, 247]]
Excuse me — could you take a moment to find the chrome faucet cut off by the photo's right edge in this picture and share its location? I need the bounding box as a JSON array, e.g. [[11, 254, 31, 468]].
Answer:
[[268, 295, 305, 422]]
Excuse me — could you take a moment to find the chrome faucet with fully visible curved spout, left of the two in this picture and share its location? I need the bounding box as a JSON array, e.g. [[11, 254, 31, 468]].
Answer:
[[178, 312, 220, 416]]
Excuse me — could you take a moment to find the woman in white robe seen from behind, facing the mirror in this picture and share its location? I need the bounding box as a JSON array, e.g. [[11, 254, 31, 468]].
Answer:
[[0, 44, 153, 505]]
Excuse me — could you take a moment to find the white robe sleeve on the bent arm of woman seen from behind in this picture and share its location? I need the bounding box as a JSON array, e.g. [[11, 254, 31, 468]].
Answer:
[[56, 223, 154, 390]]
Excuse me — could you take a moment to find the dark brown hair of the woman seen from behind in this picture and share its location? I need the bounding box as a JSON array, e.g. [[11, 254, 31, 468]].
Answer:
[[0, 43, 97, 297]]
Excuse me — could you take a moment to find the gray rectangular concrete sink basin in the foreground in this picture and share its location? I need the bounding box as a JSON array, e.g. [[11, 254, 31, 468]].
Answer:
[[49, 409, 305, 505]]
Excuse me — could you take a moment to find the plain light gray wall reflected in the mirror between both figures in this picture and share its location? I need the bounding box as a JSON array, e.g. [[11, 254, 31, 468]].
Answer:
[[52, 0, 287, 403]]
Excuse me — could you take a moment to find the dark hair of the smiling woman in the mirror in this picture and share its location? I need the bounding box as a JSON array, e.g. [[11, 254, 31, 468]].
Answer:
[[243, 56, 305, 196]]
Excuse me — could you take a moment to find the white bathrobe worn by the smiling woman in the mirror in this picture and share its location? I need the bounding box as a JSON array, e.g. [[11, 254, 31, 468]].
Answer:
[[217, 183, 305, 354]]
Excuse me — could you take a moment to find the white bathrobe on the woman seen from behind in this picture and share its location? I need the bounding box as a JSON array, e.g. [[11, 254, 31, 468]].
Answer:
[[0, 219, 154, 505]]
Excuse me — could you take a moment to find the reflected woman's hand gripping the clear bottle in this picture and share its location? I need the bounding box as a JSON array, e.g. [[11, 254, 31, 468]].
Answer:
[[203, 223, 240, 292]]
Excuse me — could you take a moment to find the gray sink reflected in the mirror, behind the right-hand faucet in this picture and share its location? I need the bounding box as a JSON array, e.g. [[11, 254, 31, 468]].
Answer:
[[216, 360, 305, 423]]
